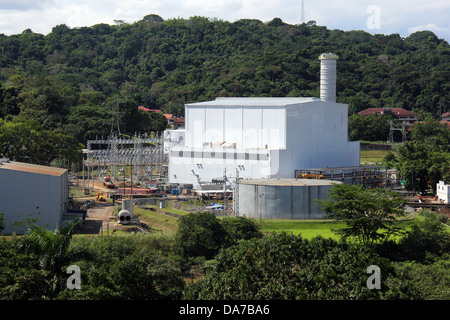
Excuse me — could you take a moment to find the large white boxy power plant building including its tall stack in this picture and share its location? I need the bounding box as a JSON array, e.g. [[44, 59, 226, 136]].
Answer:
[[168, 54, 360, 186]]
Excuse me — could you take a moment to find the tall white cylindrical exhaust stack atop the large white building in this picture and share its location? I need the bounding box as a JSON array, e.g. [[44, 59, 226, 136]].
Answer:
[[319, 53, 339, 102]]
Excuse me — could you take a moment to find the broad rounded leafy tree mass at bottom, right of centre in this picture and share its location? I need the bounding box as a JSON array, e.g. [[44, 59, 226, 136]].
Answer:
[[187, 234, 393, 300]]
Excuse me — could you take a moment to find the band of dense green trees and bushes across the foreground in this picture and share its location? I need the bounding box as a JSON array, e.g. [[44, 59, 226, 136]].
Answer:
[[0, 205, 450, 300]]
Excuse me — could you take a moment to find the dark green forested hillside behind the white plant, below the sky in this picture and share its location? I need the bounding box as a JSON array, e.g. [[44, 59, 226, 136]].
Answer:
[[0, 15, 450, 143]]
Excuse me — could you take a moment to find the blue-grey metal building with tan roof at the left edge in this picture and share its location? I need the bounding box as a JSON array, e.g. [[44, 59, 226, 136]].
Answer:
[[0, 159, 69, 234]]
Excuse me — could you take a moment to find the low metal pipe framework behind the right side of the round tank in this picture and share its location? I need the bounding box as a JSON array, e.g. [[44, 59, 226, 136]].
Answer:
[[295, 166, 398, 188]]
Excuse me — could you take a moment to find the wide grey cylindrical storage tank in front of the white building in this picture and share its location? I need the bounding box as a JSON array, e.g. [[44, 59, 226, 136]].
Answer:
[[238, 179, 341, 219]]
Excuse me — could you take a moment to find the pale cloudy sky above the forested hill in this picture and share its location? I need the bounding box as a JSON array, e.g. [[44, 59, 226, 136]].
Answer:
[[0, 0, 450, 42]]
